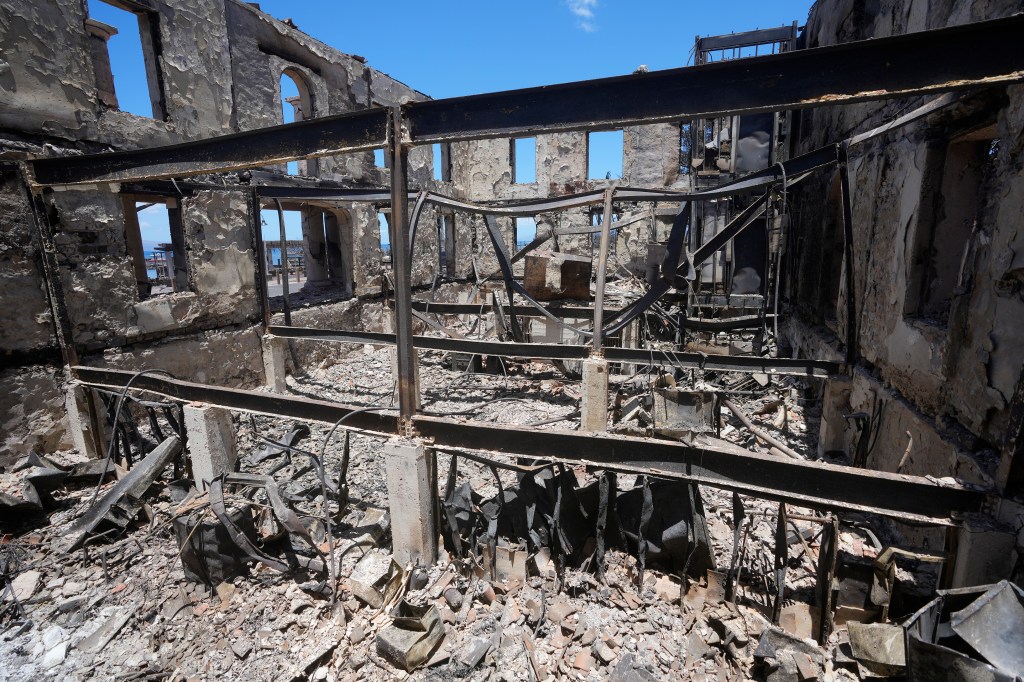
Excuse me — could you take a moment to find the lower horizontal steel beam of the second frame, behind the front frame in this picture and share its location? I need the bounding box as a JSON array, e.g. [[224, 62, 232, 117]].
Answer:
[[267, 327, 840, 379]]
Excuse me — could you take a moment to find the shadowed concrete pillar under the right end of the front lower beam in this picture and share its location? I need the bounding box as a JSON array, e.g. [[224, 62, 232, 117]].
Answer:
[[950, 514, 1017, 588]]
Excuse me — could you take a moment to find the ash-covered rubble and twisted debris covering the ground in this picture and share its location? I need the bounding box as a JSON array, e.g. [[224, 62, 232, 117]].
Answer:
[[0, 347, 958, 680]]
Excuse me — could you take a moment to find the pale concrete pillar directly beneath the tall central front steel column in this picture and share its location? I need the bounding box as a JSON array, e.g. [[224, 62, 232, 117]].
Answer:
[[384, 438, 437, 566]]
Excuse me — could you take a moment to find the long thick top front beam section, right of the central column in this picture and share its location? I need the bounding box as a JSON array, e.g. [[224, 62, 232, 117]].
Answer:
[[406, 14, 1024, 143]]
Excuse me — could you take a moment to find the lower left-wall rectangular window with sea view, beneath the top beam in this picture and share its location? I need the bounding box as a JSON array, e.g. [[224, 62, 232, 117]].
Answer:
[[124, 197, 188, 301]]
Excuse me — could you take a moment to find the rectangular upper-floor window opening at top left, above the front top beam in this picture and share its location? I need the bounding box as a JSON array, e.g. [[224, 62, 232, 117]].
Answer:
[[86, 0, 167, 121]]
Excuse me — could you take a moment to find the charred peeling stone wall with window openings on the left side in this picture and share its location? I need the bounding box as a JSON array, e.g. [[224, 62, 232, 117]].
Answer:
[[0, 0, 438, 460]]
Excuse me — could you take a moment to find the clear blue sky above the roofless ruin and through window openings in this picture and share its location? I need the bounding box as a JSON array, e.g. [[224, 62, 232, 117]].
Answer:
[[88, 0, 811, 238]]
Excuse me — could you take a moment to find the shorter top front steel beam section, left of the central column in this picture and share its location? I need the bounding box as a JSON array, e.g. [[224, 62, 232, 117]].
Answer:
[[29, 109, 387, 185]]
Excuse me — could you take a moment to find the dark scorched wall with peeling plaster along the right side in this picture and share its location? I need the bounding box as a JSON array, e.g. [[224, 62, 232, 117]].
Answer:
[[790, 0, 1024, 489]]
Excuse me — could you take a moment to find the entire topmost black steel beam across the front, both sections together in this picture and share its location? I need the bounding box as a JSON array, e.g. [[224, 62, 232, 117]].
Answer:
[[29, 14, 1024, 185]]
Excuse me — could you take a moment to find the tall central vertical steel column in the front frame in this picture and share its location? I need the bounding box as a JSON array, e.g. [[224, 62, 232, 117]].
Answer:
[[387, 106, 419, 421]]
